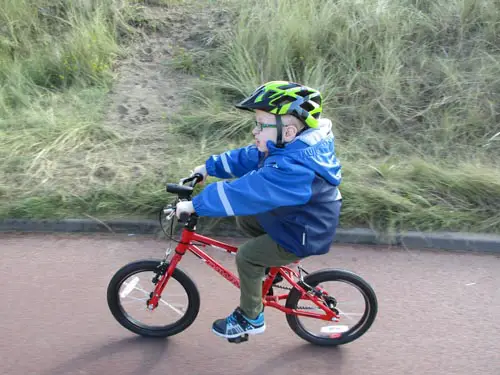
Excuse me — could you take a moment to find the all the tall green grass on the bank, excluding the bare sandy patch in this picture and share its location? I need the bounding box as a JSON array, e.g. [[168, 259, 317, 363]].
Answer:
[[0, 0, 500, 232]]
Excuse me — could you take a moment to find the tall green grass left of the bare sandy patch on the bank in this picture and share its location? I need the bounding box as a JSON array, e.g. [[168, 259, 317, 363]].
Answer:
[[0, 0, 174, 218]]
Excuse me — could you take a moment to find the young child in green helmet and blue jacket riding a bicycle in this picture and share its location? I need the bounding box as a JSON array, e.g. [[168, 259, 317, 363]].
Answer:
[[176, 81, 342, 338]]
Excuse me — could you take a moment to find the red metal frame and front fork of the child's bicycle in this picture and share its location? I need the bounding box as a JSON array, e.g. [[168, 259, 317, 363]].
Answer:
[[148, 226, 338, 321]]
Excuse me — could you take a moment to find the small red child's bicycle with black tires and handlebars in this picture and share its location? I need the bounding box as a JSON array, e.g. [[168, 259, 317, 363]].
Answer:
[[107, 174, 378, 346]]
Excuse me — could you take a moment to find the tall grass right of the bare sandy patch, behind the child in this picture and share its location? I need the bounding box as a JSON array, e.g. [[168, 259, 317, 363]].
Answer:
[[175, 0, 500, 232]]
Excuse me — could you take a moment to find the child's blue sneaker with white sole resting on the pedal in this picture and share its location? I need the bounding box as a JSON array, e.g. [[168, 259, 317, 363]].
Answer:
[[212, 307, 266, 339]]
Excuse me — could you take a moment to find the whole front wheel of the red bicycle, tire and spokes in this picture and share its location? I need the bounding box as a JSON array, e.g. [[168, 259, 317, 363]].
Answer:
[[107, 260, 200, 337]]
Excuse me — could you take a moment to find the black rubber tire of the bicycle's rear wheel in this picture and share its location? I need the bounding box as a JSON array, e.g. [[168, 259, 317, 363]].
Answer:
[[286, 269, 378, 346]]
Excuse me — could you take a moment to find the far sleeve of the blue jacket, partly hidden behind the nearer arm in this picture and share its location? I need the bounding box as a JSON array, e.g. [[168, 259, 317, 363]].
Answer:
[[205, 145, 263, 178]]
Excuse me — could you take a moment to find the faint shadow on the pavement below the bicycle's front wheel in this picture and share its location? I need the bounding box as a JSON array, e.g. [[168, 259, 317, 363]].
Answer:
[[42, 337, 168, 375]]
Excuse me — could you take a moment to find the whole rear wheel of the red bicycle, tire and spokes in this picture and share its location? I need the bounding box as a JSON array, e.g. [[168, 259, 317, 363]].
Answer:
[[286, 269, 378, 346]]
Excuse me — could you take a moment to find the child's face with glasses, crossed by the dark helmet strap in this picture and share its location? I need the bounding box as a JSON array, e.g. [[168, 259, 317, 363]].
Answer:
[[252, 110, 297, 152]]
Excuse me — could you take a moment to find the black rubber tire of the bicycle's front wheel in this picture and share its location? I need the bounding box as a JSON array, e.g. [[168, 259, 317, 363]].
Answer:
[[107, 260, 200, 337]]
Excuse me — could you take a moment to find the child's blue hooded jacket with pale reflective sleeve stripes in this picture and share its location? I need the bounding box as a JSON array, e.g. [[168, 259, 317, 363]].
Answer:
[[193, 119, 342, 257]]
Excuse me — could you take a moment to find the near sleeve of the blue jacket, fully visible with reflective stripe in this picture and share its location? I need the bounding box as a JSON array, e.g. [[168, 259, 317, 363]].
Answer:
[[193, 162, 314, 217]]
